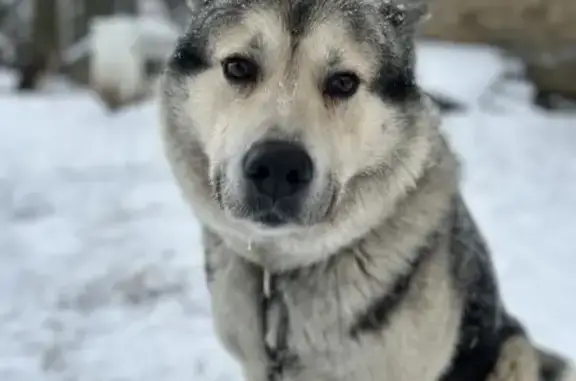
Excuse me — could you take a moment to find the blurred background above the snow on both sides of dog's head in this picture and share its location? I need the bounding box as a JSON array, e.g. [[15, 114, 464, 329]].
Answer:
[[0, 0, 576, 109]]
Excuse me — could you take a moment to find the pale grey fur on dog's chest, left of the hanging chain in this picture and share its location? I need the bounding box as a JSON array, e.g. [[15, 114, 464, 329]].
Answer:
[[204, 231, 268, 381]]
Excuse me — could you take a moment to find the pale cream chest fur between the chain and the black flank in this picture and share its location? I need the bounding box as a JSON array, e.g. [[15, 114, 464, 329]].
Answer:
[[263, 248, 459, 381]]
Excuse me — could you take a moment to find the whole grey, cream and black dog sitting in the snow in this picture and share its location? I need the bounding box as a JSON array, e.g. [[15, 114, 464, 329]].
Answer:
[[162, 0, 576, 381]]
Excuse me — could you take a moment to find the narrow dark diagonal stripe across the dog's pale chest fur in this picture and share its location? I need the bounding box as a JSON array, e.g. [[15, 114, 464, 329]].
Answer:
[[349, 226, 440, 338]]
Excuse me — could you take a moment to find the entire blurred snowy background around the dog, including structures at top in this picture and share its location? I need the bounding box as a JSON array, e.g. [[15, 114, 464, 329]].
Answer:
[[0, 0, 576, 381]]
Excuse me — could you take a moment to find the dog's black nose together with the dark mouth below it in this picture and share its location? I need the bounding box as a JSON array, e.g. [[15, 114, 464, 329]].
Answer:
[[242, 140, 314, 226]]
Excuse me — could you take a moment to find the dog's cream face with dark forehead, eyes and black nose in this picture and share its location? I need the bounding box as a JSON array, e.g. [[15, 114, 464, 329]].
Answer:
[[164, 0, 434, 262]]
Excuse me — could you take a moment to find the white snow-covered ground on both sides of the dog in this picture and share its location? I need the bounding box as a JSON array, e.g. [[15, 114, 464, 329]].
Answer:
[[0, 40, 576, 381]]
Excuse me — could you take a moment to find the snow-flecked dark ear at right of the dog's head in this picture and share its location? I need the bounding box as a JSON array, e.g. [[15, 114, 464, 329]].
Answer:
[[381, 0, 429, 32]]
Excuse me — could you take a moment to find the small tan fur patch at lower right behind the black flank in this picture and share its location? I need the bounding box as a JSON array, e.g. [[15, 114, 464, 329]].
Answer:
[[487, 336, 539, 381]]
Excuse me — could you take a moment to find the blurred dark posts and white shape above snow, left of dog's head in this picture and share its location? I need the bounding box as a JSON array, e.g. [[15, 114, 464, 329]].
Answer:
[[0, 0, 189, 109]]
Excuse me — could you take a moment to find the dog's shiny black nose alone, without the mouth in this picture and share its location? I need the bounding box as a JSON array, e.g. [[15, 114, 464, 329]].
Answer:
[[243, 141, 313, 201]]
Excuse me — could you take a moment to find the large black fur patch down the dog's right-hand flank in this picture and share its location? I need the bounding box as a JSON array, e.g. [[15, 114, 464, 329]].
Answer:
[[440, 196, 523, 381]]
